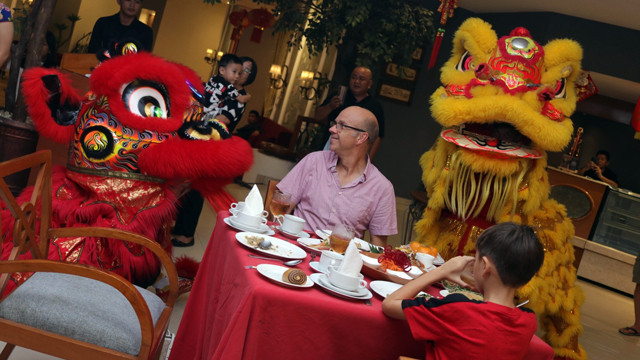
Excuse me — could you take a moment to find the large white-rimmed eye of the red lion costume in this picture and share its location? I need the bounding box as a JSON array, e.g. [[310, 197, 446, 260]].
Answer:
[[122, 80, 170, 119]]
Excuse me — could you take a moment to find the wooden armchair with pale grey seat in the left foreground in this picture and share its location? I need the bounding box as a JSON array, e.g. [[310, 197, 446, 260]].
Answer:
[[0, 150, 178, 359]]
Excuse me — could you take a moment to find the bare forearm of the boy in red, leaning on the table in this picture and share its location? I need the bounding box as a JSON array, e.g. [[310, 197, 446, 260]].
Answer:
[[382, 256, 475, 320]]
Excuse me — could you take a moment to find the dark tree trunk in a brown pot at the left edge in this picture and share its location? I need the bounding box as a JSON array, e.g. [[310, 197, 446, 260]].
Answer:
[[0, 0, 56, 193]]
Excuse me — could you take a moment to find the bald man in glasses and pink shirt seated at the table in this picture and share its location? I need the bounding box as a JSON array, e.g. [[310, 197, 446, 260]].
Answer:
[[278, 106, 398, 245]]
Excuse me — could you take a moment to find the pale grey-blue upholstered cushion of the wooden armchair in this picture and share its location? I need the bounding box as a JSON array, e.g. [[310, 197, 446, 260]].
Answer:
[[0, 272, 165, 355]]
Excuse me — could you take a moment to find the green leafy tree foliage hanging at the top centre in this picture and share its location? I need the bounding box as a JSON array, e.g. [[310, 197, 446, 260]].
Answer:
[[203, 0, 435, 87]]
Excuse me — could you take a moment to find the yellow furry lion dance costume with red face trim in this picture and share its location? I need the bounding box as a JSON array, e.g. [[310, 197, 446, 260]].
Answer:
[[416, 18, 587, 359]]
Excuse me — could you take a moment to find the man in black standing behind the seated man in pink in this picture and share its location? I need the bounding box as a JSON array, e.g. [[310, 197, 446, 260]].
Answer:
[[315, 66, 384, 158]]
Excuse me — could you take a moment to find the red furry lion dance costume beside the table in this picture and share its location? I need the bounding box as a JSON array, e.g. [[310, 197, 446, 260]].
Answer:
[[2, 49, 253, 291]]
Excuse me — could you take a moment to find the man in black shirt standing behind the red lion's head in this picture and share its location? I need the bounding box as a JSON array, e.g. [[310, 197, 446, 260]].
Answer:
[[88, 0, 153, 53]]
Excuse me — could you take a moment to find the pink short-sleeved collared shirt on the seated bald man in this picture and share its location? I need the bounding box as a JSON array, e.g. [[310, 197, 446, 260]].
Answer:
[[278, 151, 398, 238]]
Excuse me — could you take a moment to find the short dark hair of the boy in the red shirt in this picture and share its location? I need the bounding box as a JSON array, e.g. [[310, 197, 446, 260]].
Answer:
[[476, 222, 544, 288]]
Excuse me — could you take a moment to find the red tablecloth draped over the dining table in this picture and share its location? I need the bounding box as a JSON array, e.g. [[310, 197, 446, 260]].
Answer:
[[169, 211, 550, 360]]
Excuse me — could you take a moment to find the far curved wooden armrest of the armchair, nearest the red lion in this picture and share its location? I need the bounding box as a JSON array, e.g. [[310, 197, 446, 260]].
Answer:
[[48, 227, 178, 307]]
